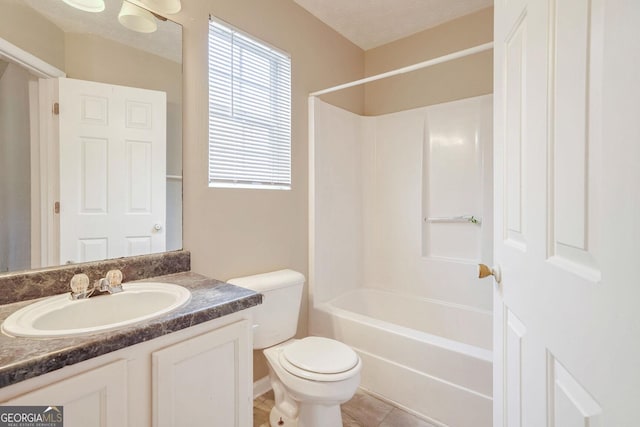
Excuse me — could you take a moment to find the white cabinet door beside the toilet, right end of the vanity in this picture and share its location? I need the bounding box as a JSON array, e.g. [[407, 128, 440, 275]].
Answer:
[[152, 320, 252, 427]]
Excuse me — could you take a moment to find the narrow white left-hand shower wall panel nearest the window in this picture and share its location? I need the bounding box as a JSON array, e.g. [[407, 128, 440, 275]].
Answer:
[[309, 98, 367, 301]]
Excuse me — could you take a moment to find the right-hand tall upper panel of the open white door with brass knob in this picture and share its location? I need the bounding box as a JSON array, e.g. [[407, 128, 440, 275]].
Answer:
[[547, 0, 603, 282]]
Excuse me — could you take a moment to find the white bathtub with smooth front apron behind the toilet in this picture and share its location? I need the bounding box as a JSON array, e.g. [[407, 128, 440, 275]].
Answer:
[[310, 288, 492, 427]]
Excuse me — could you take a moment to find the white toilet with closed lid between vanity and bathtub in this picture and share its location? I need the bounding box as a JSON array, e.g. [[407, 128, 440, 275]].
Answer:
[[227, 270, 362, 427]]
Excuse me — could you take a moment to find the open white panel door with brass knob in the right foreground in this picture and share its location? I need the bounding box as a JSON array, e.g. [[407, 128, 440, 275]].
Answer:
[[493, 0, 640, 427]]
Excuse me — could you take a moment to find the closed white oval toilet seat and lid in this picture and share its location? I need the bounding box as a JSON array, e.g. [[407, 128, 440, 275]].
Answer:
[[279, 337, 360, 382]]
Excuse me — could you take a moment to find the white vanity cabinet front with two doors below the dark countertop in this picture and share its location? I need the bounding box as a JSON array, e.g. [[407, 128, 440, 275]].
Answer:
[[0, 310, 253, 427]]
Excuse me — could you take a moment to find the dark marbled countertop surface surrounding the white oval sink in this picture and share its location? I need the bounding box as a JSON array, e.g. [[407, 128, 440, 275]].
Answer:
[[0, 272, 262, 387]]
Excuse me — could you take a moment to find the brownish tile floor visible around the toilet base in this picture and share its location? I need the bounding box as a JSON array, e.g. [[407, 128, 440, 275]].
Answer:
[[253, 390, 436, 427]]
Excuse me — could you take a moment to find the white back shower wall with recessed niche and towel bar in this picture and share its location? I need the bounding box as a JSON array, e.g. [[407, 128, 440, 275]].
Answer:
[[363, 96, 493, 309]]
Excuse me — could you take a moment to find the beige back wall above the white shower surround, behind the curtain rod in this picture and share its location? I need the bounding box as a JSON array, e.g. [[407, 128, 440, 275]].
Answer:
[[365, 8, 493, 116]]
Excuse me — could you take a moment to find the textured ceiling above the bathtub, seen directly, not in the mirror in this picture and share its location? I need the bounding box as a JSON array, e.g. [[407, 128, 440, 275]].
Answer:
[[294, 0, 493, 50]]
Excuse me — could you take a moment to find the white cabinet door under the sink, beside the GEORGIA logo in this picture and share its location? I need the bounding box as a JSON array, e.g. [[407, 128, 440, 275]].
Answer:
[[2, 360, 128, 427]]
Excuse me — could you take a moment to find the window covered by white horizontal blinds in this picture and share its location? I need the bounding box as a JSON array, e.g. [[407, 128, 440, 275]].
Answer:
[[209, 19, 291, 189]]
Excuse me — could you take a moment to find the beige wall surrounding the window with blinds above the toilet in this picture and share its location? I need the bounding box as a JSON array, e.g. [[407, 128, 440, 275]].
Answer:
[[165, 0, 364, 379]]
